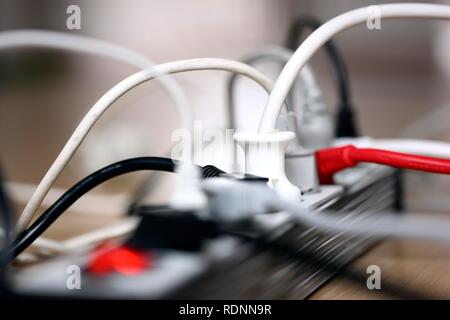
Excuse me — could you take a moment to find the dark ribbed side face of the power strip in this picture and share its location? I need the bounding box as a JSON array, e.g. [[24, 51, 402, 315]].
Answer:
[[175, 166, 397, 299]]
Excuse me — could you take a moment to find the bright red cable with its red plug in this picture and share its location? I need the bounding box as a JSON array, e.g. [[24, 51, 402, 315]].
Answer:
[[316, 145, 450, 184]]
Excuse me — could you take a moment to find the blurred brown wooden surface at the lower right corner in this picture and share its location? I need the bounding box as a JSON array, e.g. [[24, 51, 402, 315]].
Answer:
[[310, 240, 450, 300]]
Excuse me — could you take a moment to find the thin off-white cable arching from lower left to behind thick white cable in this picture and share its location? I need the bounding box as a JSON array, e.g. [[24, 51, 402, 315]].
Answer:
[[17, 58, 282, 230]]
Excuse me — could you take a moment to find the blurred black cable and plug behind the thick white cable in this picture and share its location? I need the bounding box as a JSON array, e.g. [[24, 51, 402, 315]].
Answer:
[[286, 16, 358, 138]]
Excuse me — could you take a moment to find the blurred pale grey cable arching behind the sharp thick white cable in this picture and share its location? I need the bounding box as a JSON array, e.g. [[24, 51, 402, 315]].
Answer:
[[227, 46, 322, 127]]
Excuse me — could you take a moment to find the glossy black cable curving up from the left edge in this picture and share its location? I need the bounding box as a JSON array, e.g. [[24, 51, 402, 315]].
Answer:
[[2, 157, 224, 262]]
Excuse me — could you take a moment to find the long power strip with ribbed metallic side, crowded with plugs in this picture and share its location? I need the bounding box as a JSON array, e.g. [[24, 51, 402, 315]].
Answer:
[[13, 166, 397, 299]]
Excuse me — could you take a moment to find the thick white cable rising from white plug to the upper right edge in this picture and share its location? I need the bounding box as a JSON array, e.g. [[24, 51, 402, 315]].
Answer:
[[259, 3, 450, 133]]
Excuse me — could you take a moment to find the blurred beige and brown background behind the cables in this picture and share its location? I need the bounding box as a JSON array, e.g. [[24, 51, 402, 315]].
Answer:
[[0, 0, 450, 221]]
